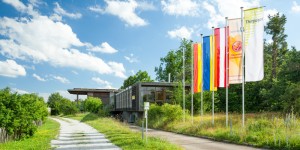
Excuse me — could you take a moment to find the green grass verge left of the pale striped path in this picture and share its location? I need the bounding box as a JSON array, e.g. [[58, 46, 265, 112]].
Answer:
[[0, 118, 59, 150]]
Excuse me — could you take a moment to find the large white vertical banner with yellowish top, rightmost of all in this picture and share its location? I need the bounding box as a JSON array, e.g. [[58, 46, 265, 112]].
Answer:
[[244, 7, 264, 81]]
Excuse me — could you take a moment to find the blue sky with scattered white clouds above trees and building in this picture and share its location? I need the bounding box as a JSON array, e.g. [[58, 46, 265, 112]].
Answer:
[[0, 0, 300, 99]]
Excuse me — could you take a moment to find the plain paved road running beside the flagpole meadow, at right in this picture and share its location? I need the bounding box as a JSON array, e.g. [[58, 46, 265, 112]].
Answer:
[[130, 125, 264, 150]]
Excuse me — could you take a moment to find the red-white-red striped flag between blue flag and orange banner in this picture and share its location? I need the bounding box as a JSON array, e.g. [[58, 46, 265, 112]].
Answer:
[[214, 28, 227, 87]]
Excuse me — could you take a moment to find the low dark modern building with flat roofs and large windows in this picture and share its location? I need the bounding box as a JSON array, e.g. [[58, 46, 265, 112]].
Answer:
[[68, 82, 190, 122]]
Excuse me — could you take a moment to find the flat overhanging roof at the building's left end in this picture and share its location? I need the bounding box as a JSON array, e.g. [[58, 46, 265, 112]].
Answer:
[[68, 88, 119, 95]]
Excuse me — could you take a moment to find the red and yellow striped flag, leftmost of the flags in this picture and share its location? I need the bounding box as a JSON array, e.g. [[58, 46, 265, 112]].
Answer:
[[193, 43, 202, 93]]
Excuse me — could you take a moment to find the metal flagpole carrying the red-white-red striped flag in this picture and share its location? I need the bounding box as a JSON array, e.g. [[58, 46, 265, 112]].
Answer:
[[211, 27, 215, 126]]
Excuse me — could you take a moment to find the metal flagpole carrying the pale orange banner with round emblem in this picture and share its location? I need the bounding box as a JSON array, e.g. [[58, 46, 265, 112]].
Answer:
[[225, 17, 229, 128]]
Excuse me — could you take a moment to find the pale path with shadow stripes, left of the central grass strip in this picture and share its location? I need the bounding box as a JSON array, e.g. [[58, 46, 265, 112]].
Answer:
[[51, 118, 120, 150]]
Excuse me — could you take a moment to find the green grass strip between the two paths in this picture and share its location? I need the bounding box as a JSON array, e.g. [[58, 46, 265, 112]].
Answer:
[[68, 113, 182, 150]]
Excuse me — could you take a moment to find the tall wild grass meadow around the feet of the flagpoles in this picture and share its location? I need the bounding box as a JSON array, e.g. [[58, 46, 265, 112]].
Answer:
[[149, 113, 300, 149]]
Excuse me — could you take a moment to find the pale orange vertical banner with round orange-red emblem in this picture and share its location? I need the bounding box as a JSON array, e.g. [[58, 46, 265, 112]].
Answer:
[[228, 18, 242, 84]]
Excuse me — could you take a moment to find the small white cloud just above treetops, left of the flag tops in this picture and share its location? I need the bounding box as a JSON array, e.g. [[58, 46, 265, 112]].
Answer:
[[168, 26, 193, 39]]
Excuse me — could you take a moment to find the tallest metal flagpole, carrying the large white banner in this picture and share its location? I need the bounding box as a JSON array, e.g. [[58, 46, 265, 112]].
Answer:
[[241, 7, 245, 127]]
